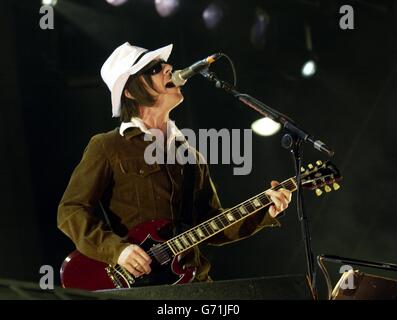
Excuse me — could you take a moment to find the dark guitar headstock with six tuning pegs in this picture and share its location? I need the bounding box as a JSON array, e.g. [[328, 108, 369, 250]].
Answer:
[[301, 160, 342, 196]]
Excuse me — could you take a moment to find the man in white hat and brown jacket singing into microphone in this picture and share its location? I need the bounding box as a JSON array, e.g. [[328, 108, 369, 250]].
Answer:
[[58, 43, 291, 281]]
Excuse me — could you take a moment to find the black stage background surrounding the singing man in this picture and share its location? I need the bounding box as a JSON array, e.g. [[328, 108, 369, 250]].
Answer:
[[0, 0, 397, 298]]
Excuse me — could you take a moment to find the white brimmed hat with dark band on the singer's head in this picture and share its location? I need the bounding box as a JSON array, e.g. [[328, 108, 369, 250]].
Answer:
[[101, 42, 172, 117]]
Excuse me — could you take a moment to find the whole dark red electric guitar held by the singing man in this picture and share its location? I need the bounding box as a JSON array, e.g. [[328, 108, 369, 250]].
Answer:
[[61, 161, 342, 290]]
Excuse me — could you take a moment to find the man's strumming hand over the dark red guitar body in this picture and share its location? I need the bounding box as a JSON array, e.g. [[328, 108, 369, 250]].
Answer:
[[117, 244, 152, 277]]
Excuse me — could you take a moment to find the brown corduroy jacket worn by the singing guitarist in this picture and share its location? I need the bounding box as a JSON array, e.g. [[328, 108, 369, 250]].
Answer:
[[58, 128, 280, 281]]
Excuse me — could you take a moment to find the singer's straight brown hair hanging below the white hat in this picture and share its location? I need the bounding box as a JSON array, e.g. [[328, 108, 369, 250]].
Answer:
[[120, 68, 156, 122]]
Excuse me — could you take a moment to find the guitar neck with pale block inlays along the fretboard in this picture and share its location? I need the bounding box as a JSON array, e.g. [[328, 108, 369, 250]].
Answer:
[[166, 178, 297, 255]]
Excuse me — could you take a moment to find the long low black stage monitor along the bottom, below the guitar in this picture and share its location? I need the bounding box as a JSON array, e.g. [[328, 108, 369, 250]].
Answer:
[[0, 275, 312, 300]]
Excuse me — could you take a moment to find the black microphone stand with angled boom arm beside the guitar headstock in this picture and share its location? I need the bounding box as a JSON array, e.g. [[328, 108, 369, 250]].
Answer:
[[200, 68, 334, 299]]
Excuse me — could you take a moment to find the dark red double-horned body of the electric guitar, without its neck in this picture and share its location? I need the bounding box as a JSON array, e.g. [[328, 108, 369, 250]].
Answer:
[[61, 220, 196, 291]]
